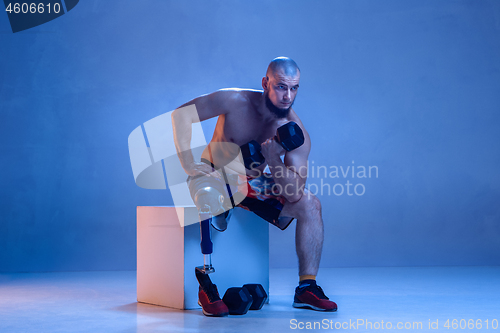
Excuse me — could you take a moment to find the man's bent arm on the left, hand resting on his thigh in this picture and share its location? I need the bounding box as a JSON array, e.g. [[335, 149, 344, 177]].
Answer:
[[172, 90, 241, 176]]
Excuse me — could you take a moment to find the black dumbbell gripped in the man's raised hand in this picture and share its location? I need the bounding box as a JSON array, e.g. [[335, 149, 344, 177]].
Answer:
[[240, 121, 304, 169]]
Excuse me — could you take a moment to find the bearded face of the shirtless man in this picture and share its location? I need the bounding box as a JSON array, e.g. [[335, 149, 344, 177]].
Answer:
[[263, 69, 300, 118]]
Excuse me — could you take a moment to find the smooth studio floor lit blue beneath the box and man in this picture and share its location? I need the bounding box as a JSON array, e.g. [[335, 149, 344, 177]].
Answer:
[[0, 267, 500, 333]]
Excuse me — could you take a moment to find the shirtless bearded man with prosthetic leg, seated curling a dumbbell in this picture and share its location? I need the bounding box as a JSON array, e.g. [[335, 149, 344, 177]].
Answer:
[[172, 57, 337, 316]]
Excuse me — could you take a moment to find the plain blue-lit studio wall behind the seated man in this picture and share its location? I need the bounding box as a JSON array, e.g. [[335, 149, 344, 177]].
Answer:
[[0, 0, 500, 272]]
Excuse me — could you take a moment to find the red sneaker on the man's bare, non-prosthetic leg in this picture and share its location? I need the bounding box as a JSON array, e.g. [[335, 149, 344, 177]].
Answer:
[[293, 280, 337, 311]]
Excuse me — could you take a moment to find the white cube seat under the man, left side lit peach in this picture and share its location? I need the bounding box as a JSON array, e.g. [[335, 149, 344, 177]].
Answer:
[[137, 206, 269, 309]]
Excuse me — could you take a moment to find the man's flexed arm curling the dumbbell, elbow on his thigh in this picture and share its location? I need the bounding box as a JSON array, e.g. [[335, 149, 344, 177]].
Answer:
[[262, 124, 311, 202]]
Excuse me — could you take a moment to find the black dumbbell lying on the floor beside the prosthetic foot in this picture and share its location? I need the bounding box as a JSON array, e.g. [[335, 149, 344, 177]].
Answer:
[[222, 283, 267, 315]]
